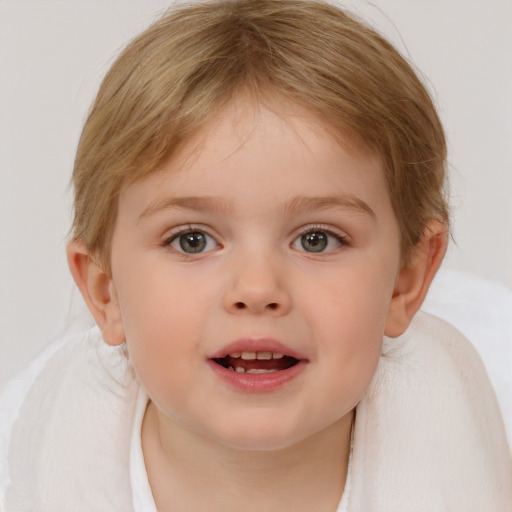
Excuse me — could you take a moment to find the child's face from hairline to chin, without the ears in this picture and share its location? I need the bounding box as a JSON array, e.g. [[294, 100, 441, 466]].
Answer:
[[112, 104, 400, 449]]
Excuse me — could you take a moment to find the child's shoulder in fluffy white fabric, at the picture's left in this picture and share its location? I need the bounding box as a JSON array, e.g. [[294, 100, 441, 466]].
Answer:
[[0, 328, 138, 510]]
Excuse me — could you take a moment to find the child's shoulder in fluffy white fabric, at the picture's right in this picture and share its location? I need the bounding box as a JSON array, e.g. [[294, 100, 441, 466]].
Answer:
[[353, 313, 512, 512]]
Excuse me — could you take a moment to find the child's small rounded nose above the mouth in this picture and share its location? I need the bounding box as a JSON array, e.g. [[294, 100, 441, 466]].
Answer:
[[223, 255, 292, 316]]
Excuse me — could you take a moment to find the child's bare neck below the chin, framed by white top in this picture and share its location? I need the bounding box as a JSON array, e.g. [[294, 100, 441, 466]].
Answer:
[[142, 403, 353, 512]]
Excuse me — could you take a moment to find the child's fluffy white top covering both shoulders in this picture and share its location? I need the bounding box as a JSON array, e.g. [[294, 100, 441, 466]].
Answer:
[[0, 313, 512, 512]]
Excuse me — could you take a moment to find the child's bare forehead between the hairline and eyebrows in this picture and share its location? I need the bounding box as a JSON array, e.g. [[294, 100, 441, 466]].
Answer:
[[120, 100, 390, 226]]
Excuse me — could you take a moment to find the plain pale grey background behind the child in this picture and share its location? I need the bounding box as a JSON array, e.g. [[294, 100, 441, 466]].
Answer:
[[0, 0, 512, 388]]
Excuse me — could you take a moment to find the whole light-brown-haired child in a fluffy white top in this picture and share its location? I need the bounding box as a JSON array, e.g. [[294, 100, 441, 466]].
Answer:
[[0, 0, 512, 512]]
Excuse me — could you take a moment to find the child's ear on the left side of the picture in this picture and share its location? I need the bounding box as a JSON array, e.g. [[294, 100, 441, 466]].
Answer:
[[67, 240, 126, 345]]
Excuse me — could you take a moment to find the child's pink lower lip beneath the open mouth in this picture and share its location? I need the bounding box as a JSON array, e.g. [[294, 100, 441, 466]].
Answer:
[[208, 359, 307, 393]]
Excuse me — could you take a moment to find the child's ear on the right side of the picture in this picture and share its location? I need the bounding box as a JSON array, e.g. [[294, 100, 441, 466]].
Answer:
[[384, 220, 448, 338]]
